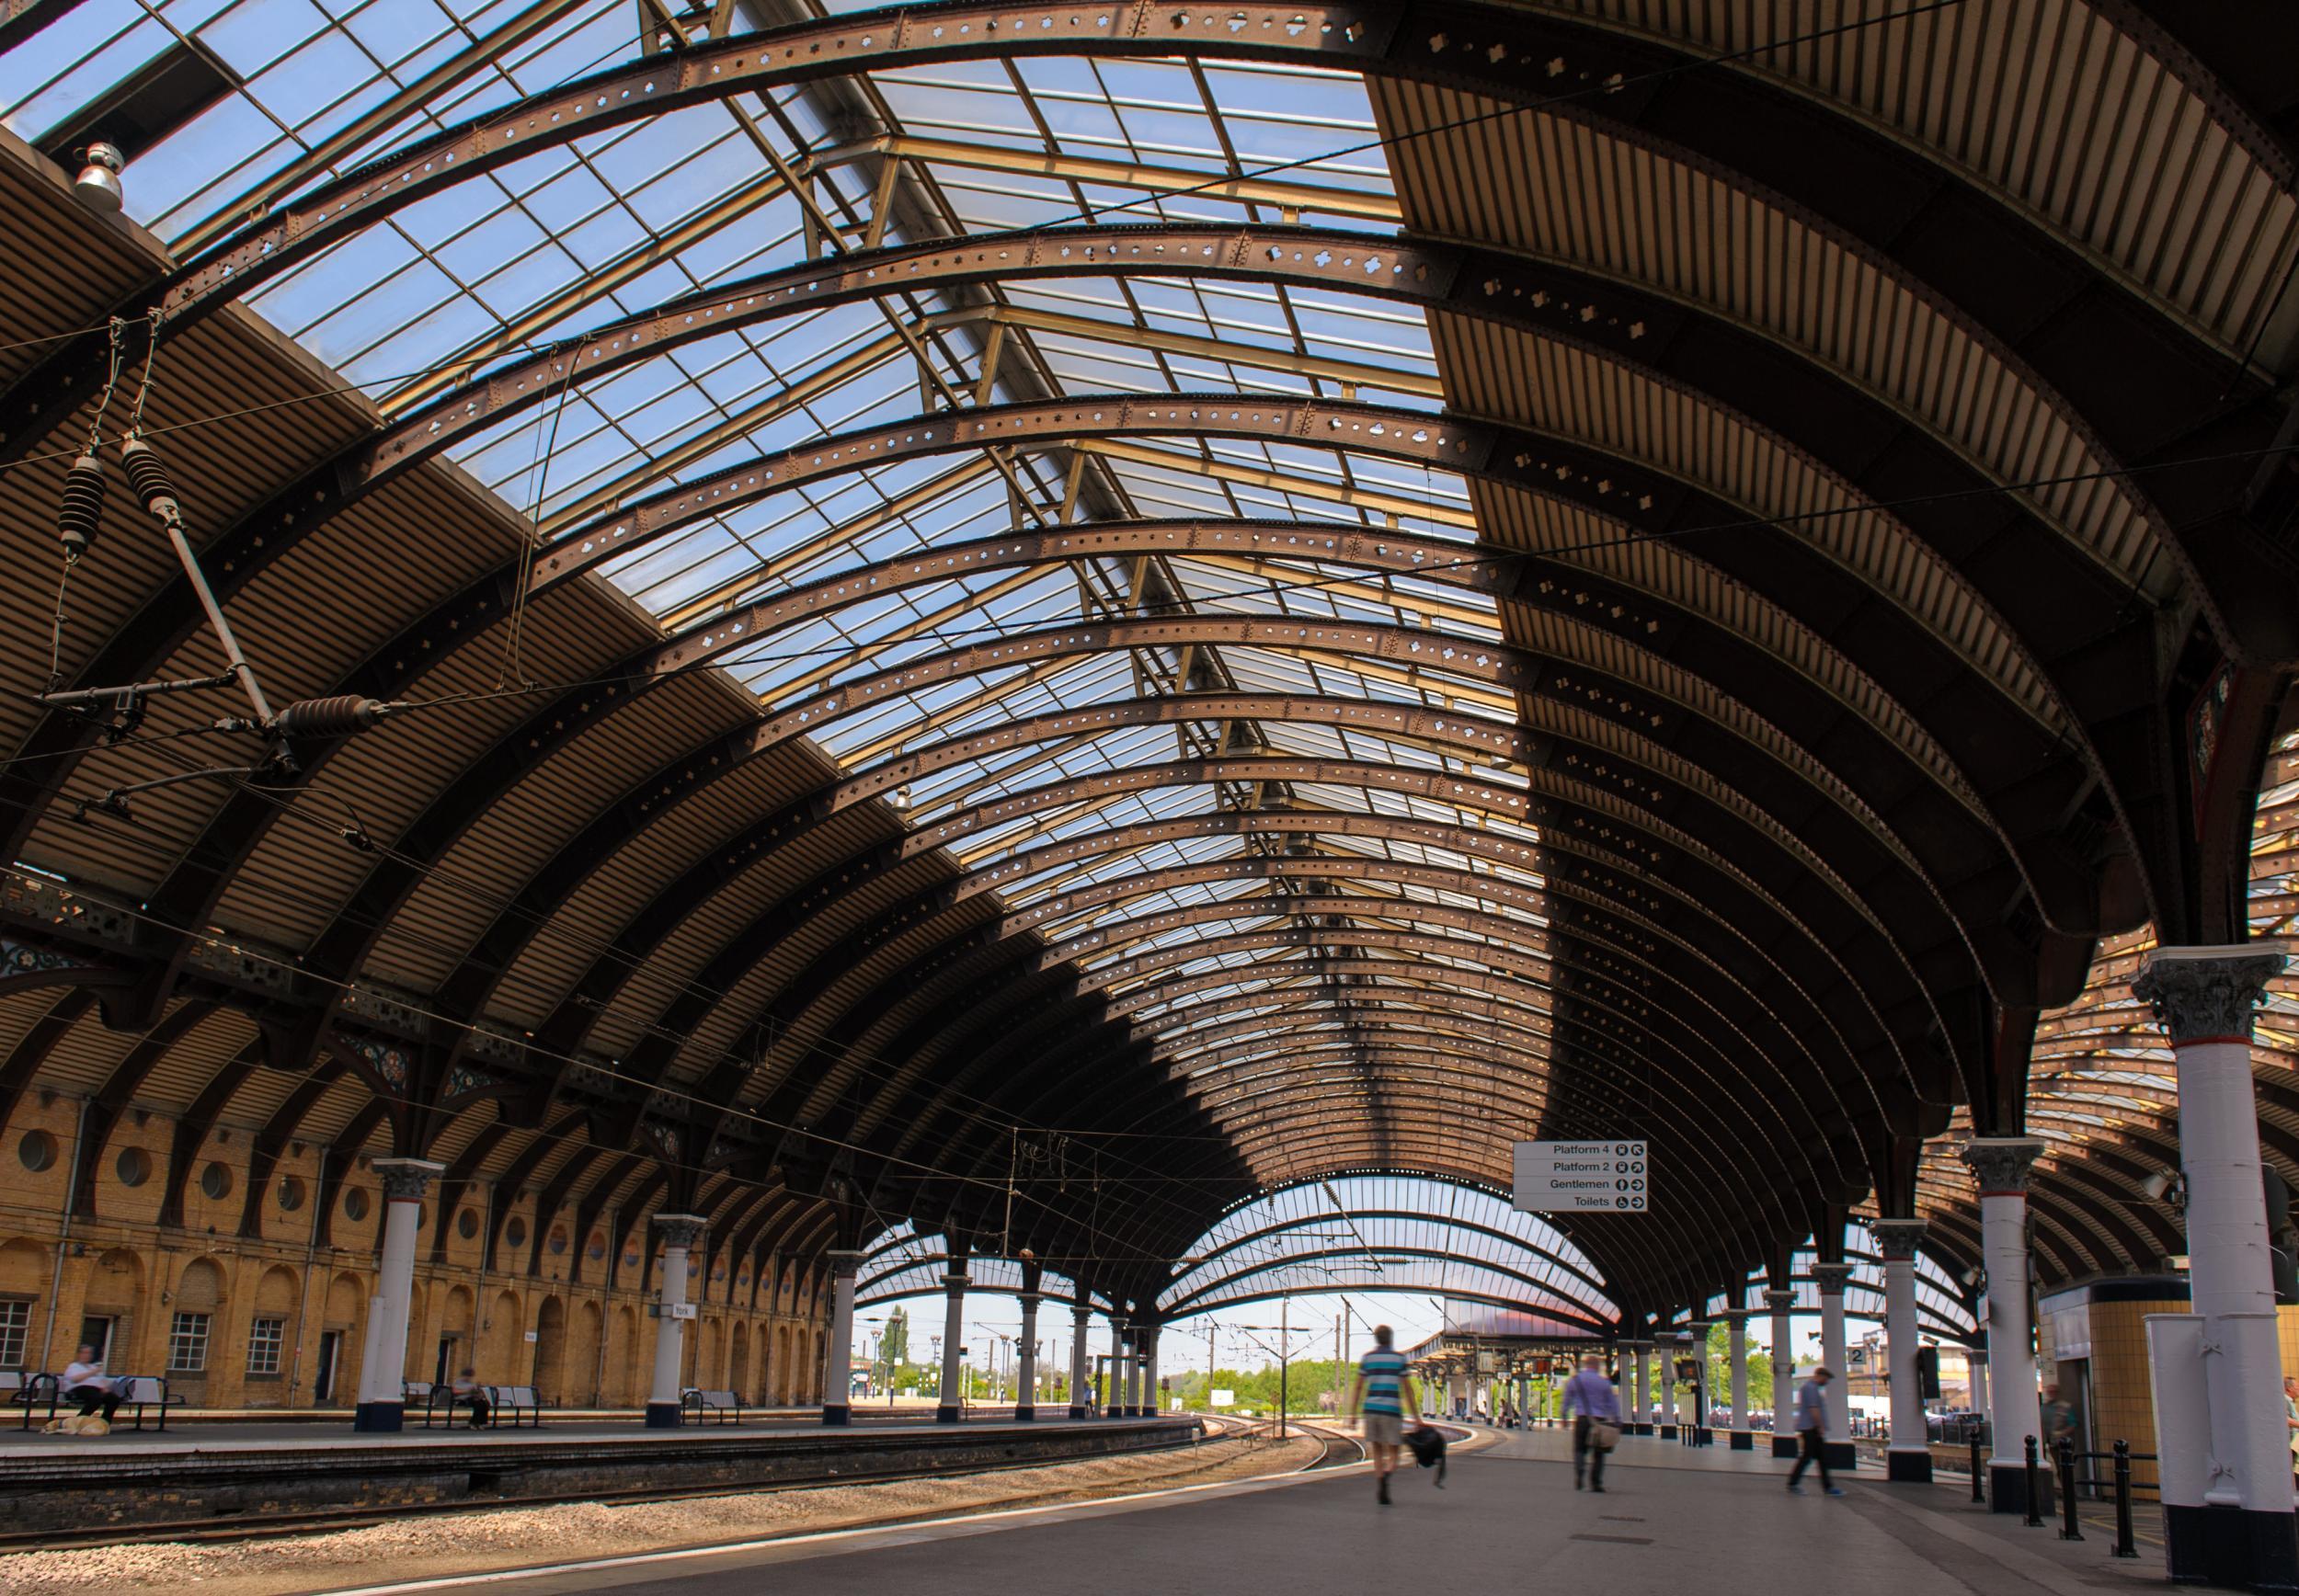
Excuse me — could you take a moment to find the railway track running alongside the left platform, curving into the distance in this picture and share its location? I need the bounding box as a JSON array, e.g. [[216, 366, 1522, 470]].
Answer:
[[0, 1419, 1333, 1555]]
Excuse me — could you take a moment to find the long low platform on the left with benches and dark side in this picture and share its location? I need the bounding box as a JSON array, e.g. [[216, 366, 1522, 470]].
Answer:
[[0, 1414, 1200, 1533]]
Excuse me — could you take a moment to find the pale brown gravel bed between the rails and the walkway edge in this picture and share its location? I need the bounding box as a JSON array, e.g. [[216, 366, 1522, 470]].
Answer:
[[0, 1440, 1318, 1596]]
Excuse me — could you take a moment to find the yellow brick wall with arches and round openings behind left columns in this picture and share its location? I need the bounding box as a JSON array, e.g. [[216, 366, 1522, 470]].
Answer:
[[0, 1090, 828, 1408]]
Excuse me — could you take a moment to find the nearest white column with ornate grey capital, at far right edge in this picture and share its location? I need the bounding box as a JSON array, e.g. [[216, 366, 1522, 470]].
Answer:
[[2133, 943, 2299, 1589]]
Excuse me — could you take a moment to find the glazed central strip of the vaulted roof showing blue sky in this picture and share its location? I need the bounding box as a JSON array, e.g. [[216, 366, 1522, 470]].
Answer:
[[0, 0, 1545, 1223]]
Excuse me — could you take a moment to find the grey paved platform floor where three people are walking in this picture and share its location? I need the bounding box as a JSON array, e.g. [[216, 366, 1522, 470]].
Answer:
[[310, 1432, 2164, 1596]]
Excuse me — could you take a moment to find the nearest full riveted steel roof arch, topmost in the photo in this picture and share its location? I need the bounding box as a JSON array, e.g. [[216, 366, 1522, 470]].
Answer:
[[27, 0, 2283, 667]]
